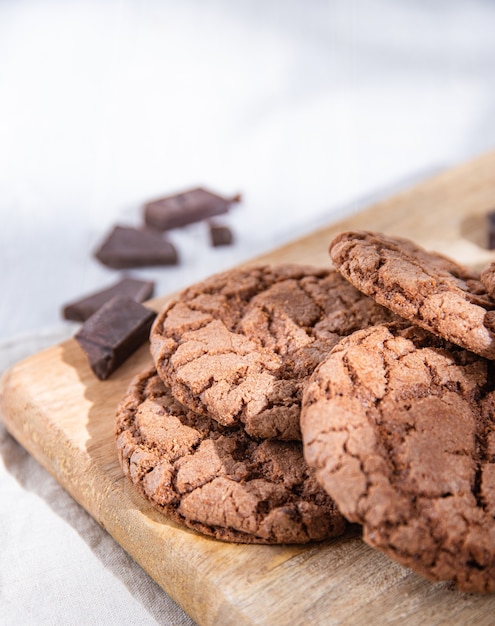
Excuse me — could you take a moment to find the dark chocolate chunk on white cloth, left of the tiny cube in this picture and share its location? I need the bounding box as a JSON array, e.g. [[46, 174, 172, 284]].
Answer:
[[95, 226, 178, 269]]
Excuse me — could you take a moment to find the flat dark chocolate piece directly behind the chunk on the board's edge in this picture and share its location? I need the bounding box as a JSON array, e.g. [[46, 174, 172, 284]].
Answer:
[[63, 278, 155, 322]]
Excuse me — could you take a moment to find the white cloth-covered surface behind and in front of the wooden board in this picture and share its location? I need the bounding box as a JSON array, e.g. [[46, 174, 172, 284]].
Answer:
[[0, 0, 495, 626]]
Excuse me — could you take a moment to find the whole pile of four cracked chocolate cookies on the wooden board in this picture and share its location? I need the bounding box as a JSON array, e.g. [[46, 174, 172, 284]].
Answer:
[[117, 232, 495, 592]]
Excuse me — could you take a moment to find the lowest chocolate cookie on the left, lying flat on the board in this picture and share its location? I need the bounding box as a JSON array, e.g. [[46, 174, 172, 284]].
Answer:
[[116, 370, 346, 544]]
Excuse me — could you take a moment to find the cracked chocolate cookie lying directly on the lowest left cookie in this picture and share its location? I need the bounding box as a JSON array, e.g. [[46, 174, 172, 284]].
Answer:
[[151, 265, 393, 440]]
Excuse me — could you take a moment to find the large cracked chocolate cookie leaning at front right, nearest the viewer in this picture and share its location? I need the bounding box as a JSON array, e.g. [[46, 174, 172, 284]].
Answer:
[[301, 325, 495, 592]]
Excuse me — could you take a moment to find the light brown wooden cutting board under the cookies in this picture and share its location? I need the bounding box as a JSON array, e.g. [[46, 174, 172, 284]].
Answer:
[[0, 152, 495, 626]]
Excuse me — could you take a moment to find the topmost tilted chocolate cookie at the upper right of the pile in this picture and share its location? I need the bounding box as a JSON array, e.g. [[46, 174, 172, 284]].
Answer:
[[330, 232, 495, 359]]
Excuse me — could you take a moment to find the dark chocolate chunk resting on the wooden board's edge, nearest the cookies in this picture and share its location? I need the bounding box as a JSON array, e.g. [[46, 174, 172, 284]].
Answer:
[[75, 296, 156, 380]]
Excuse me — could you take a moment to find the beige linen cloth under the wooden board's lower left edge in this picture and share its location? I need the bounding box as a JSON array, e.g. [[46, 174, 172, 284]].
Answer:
[[0, 329, 194, 626]]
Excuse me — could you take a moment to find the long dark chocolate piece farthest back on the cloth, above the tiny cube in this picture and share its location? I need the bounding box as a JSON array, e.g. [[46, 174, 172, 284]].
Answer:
[[144, 187, 241, 230]]
